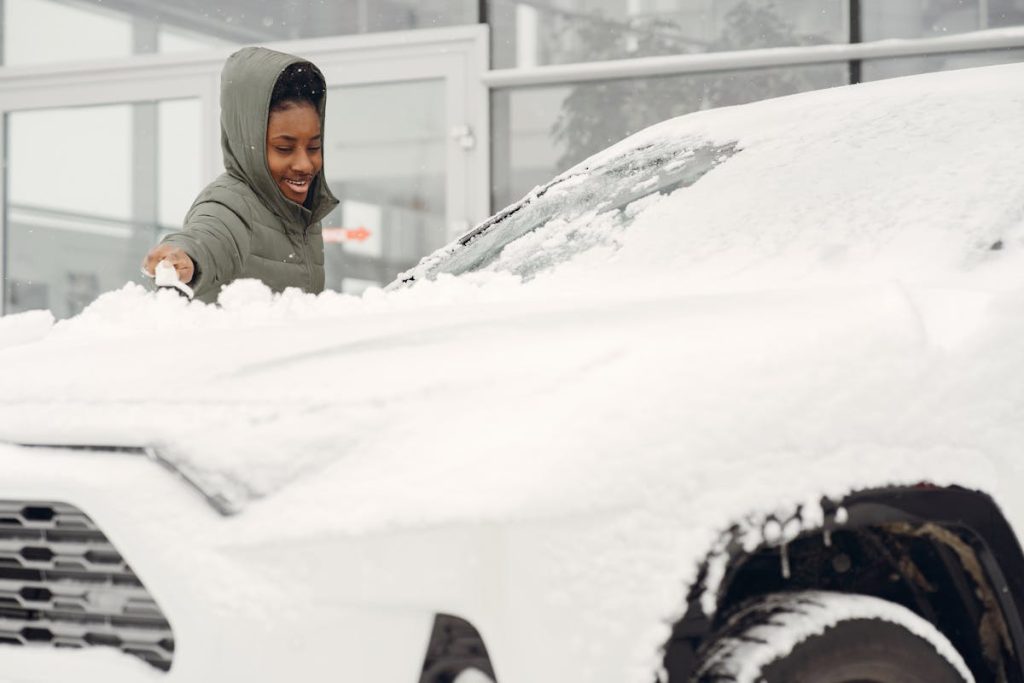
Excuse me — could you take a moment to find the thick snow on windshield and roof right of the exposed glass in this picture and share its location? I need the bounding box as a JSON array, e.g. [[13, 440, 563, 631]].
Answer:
[[570, 67, 1024, 290]]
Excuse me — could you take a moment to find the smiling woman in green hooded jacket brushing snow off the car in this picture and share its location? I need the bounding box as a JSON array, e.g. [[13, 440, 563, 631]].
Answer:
[[142, 47, 338, 302]]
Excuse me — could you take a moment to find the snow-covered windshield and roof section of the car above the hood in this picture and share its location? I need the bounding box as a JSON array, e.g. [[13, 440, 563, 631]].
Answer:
[[402, 60, 1024, 291]]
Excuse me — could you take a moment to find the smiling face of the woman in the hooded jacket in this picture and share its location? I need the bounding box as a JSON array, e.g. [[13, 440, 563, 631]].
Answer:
[[266, 101, 324, 204]]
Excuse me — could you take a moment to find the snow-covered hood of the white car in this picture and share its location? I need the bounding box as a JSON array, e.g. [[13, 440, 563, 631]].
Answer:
[[0, 285, 1003, 525]]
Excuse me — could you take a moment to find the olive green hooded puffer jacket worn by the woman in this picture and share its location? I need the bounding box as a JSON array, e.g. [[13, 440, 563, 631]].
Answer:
[[163, 47, 338, 302]]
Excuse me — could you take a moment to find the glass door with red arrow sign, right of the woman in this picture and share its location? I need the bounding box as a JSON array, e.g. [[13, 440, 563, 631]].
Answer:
[[317, 27, 488, 293]]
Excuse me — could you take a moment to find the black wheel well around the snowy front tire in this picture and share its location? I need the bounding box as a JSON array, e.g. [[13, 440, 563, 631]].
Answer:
[[665, 487, 1024, 683]]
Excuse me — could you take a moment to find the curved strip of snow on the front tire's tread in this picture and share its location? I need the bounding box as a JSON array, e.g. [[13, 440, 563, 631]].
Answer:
[[704, 591, 974, 683]]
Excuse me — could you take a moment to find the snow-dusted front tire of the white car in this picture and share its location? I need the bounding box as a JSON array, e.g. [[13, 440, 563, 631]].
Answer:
[[693, 591, 974, 683]]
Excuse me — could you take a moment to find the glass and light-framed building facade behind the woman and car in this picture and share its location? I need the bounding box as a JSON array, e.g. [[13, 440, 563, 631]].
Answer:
[[0, 0, 1024, 316]]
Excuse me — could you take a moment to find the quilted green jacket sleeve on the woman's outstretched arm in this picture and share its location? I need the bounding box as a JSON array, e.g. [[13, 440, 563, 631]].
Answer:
[[163, 201, 252, 300]]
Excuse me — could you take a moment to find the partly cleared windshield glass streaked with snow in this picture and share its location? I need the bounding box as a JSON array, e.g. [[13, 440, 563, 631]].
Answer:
[[399, 138, 737, 282]]
